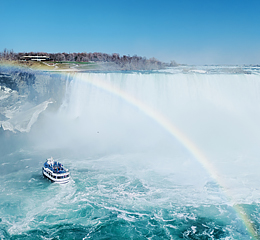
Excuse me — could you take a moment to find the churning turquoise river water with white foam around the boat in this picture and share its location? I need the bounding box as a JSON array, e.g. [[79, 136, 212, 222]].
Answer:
[[0, 151, 260, 239]]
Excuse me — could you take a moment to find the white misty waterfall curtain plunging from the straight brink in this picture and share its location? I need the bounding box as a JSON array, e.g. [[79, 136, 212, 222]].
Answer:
[[27, 73, 260, 198]]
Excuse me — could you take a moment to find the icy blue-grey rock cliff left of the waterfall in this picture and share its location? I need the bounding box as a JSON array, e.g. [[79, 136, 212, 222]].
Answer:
[[0, 67, 68, 132]]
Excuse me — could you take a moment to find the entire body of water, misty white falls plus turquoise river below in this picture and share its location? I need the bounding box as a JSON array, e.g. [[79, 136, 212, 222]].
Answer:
[[0, 67, 260, 239]]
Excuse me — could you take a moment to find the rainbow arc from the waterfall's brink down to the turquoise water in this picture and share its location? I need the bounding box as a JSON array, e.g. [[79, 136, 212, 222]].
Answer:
[[72, 73, 260, 239]]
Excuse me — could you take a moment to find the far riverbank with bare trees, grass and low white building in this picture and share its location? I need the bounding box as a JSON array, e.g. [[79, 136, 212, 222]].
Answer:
[[0, 50, 169, 72]]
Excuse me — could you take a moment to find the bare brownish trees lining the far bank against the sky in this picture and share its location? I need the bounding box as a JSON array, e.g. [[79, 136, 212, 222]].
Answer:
[[0, 49, 177, 70]]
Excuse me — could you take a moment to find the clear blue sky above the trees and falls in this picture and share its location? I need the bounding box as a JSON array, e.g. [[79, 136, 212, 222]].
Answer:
[[0, 0, 260, 64]]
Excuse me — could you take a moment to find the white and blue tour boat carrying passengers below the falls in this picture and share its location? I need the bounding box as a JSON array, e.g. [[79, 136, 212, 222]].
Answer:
[[42, 157, 70, 183]]
